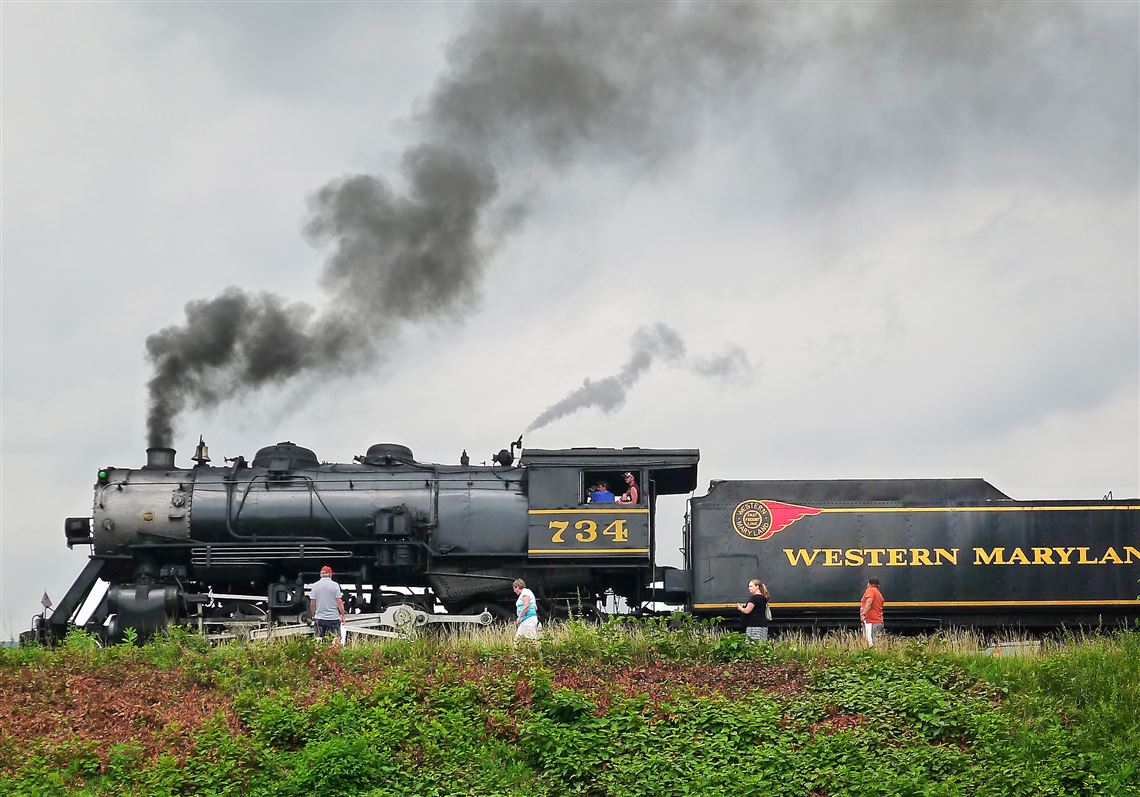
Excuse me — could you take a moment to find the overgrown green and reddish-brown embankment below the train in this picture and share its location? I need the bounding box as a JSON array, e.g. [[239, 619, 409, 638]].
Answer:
[[0, 624, 1140, 797]]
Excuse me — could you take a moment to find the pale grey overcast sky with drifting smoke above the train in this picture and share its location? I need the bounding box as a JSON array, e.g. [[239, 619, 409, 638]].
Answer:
[[0, 2, 1140, 637]]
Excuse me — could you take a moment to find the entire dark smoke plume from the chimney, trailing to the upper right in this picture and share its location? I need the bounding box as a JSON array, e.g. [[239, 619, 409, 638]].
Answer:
[[147, 2, 1121, 446]]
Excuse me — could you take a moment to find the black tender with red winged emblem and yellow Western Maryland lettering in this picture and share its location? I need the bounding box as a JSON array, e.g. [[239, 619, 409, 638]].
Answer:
[[682, 479, 1140, 628]]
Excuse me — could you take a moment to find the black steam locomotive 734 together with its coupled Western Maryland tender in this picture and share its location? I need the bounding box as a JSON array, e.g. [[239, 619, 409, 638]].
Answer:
[[27, 439, 1140, 642]]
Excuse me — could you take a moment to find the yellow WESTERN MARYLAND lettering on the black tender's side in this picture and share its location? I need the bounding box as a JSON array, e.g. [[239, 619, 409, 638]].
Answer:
[[783, 545, 1140, 568]]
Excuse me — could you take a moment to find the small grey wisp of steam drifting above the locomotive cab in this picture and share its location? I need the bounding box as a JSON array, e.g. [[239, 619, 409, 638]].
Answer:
[[527, 324, 751, 432]]
